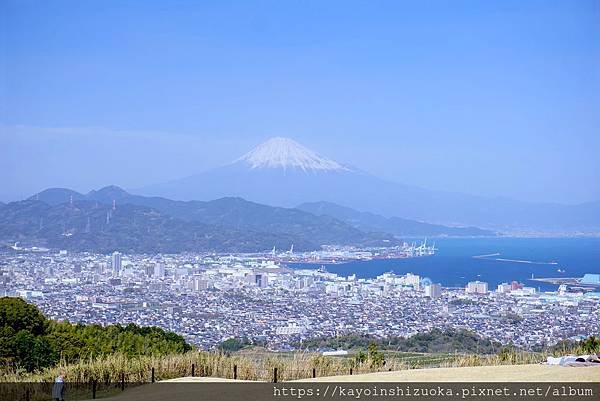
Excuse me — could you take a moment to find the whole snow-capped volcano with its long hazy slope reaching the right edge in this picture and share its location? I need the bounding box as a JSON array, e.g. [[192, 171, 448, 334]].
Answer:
[[142, 137, 600, 233]]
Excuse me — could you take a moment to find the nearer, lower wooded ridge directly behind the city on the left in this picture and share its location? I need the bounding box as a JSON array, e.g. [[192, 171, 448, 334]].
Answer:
[[0, 200, 317, 253]]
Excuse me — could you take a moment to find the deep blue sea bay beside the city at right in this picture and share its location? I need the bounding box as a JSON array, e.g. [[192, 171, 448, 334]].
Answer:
[[291, 238, 600, 291]]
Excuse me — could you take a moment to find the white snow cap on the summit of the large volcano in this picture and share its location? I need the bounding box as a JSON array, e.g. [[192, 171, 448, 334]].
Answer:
[[234, 137, 349, 171]]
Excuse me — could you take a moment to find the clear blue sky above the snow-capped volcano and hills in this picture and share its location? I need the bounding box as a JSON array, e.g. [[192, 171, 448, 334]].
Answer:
[[0, 0, 600, 203]]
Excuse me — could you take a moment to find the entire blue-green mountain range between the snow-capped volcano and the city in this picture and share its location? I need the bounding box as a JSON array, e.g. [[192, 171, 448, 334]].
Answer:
[[0, 186, 397, 252]]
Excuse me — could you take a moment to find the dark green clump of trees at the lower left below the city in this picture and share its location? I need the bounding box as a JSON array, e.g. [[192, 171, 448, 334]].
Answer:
[[0, 297, 191, 372]]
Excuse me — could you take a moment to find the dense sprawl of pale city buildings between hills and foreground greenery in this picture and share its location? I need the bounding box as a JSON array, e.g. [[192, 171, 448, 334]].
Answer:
[[0, 249, 600, 351]]
